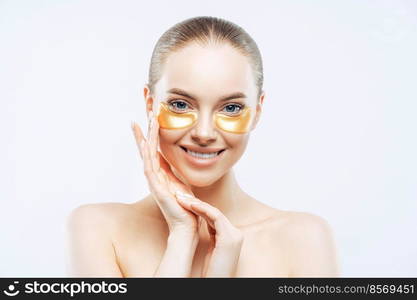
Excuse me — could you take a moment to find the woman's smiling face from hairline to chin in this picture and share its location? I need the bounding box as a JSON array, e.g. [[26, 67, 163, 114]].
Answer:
[[145, 43, 264, 187]]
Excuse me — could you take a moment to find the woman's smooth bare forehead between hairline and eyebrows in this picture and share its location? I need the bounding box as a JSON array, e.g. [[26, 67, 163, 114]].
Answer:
[[157, 43, 256, 101]]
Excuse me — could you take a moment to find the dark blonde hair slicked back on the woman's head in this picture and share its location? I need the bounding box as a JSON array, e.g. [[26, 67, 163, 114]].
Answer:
[[148, 16, 263, 98]]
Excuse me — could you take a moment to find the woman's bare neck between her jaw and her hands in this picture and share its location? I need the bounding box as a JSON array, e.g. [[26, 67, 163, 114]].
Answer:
[[191, 169, 247, 221]]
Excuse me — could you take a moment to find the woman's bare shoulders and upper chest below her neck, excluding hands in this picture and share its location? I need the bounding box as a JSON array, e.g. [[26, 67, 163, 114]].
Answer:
[[68, 192, 339, 277]]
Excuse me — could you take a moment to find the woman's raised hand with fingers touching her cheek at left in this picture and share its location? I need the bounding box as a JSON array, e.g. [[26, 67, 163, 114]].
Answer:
[[132, 111, 201, 238]]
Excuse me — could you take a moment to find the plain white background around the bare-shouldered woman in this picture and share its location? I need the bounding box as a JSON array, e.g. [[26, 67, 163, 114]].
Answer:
[[0, 0, 417, 277]]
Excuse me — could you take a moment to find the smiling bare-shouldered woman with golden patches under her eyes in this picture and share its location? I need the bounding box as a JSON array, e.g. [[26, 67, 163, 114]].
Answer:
[[68, 17, 338, 277]]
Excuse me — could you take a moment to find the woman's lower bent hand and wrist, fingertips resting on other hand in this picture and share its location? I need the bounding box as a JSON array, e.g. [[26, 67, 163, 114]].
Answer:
[[173, 193, 243, 277]]
